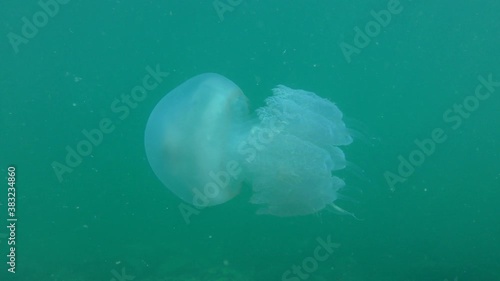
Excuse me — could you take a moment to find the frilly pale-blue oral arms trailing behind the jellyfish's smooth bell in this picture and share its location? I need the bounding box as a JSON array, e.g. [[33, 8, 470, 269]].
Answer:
[[242, 86, 352, 216]]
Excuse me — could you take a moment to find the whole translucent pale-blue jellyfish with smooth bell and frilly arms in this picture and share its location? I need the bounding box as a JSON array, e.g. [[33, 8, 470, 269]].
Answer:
[[144, 73, 352, 217]]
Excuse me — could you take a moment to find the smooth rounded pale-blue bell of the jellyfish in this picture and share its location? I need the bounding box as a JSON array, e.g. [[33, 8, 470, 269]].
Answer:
[[144, 73, 248, 206]]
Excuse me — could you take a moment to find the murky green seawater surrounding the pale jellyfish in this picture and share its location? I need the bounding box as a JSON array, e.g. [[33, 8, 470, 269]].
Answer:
[[0, 0, 500, 281]]
